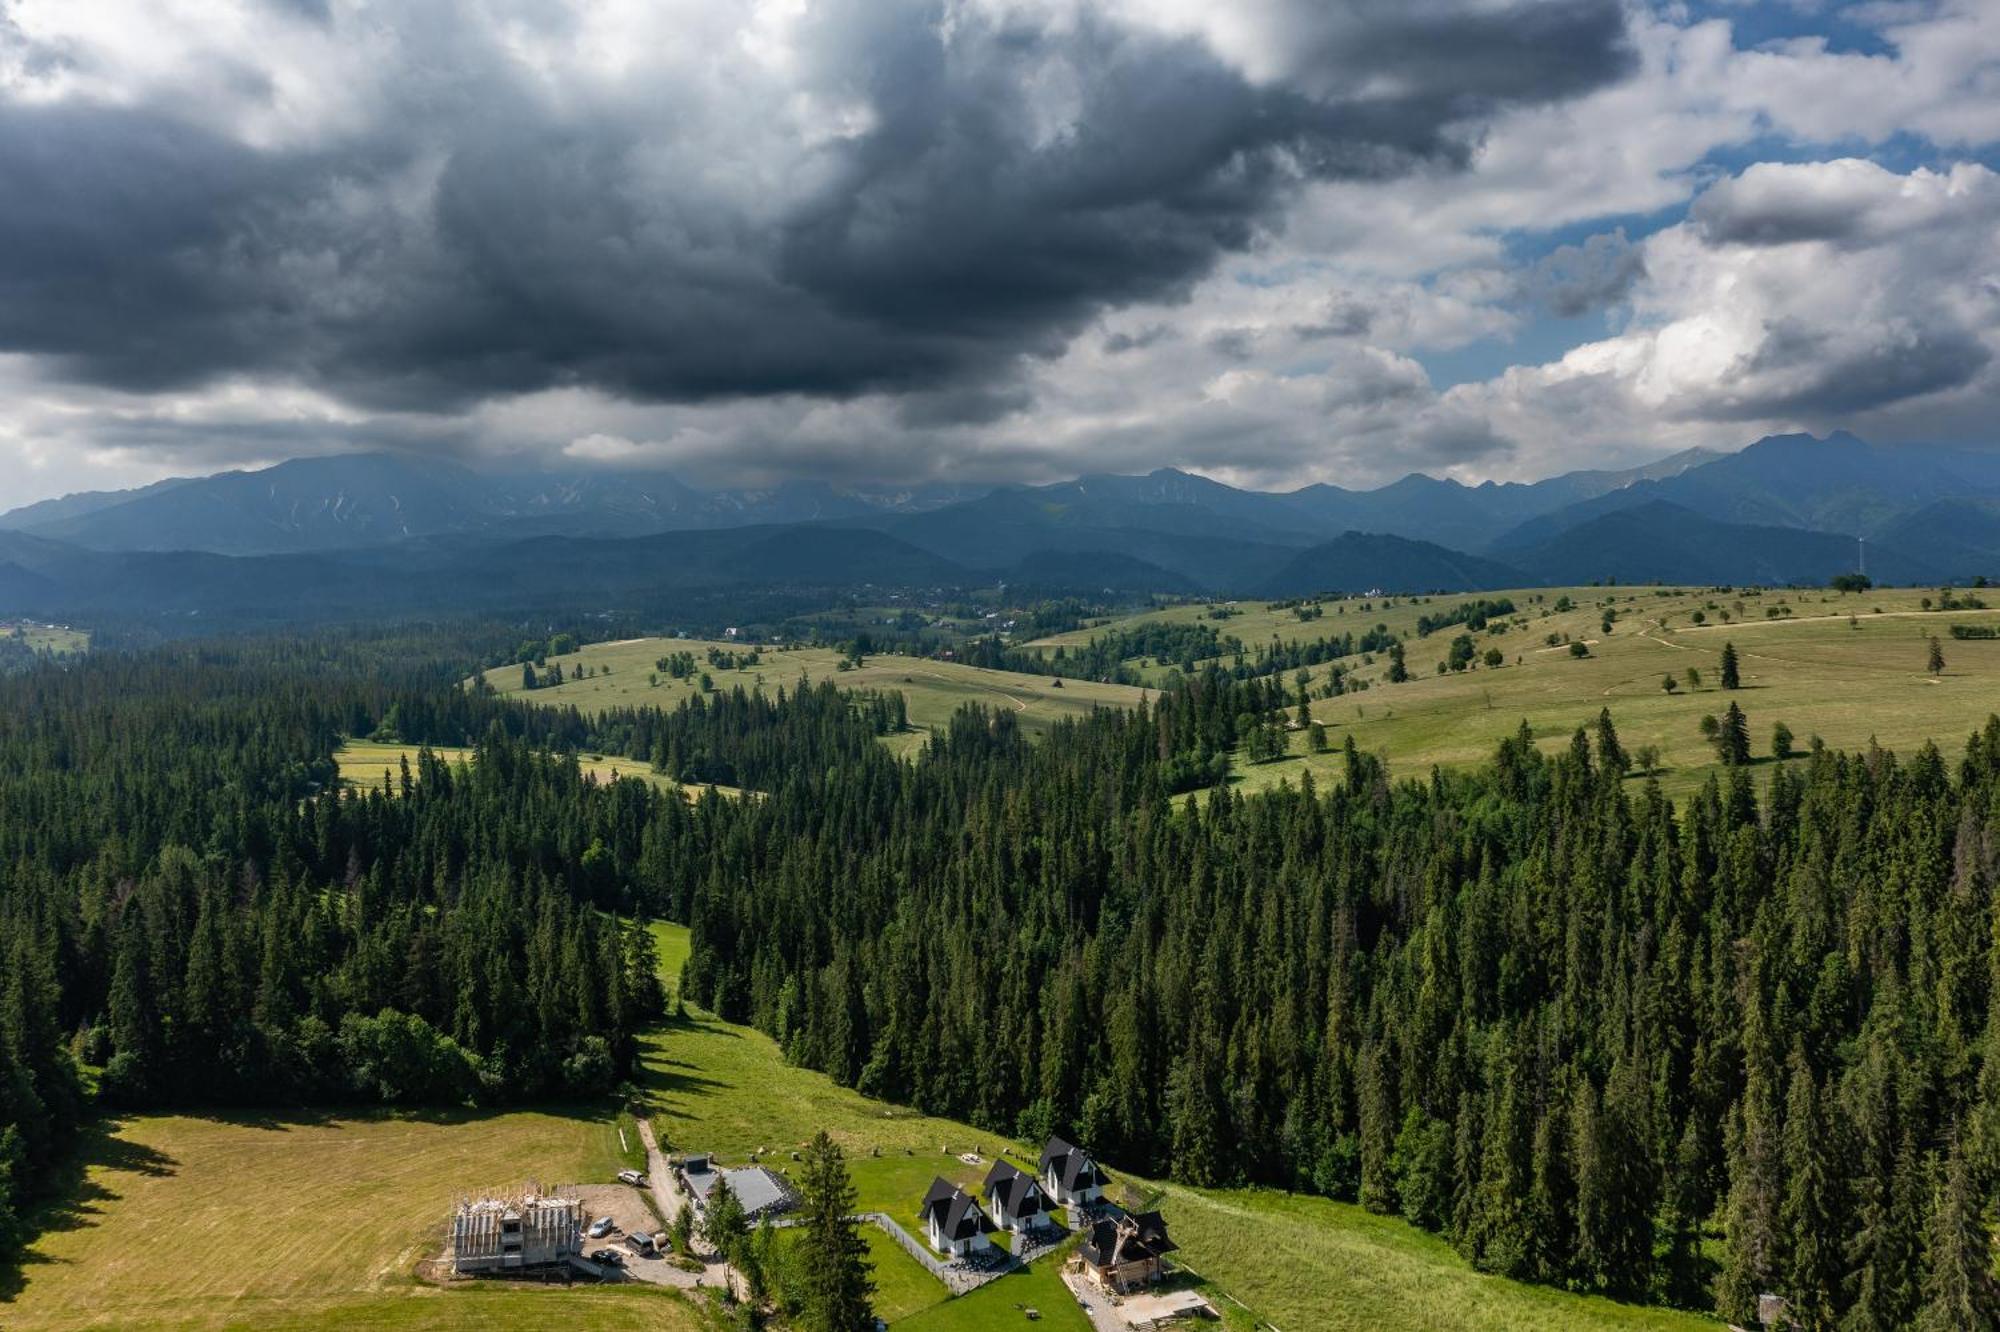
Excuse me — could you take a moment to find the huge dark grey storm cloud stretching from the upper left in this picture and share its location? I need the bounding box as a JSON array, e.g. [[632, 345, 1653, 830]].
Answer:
[[0, 0, 1628, 420]]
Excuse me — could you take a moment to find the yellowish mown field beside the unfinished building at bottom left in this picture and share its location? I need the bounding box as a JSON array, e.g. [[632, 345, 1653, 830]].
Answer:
[[0, 1112, 692, 1332]]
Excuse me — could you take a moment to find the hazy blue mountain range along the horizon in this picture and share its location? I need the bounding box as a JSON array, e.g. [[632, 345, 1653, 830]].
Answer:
[[0, 432, 2000, 616]]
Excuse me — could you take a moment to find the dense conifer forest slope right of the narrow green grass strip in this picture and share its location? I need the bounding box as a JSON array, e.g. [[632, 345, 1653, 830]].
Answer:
[[670, 678, 2000, 1328]]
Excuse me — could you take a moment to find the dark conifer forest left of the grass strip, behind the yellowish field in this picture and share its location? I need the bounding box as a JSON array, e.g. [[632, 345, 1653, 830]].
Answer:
[[0, 640, 896, 1256]]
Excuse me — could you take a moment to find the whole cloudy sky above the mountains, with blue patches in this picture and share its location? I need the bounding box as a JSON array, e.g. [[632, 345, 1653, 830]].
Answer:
[[0, 0, 2000, 508]]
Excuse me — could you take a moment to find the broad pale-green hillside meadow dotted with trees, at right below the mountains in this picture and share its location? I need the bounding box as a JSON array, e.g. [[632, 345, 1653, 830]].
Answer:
[[1016, 588, 2000, 794]]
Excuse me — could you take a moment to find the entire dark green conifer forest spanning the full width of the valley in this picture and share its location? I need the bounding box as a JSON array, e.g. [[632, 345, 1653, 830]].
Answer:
[[0, 638, 2000, 1328]]
